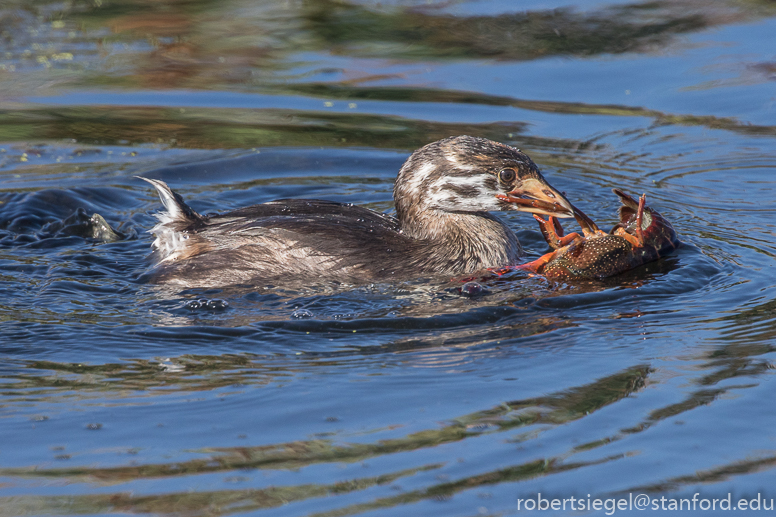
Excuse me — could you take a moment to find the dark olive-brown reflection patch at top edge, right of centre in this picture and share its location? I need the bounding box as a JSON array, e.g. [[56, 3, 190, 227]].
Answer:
[[305, 0, 713, 60]]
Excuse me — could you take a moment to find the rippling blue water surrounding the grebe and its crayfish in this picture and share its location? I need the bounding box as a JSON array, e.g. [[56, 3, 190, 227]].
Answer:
[[0, 0, 776, 517]]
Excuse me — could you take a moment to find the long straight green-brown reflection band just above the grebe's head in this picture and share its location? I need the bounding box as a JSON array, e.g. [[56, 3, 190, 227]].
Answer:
[[0, 107, 524, 149]]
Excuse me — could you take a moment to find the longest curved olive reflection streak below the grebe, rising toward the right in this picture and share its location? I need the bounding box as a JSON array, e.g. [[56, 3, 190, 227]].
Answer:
[[0, 363, 649, 483]]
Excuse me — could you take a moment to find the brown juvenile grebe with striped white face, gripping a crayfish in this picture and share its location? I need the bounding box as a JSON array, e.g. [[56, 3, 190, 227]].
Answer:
[[141, 136, 573, 287]]
